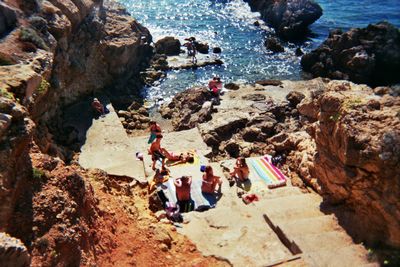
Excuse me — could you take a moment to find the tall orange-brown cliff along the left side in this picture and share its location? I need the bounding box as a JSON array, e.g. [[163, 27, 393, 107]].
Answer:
[[0, 0, 152, 266]]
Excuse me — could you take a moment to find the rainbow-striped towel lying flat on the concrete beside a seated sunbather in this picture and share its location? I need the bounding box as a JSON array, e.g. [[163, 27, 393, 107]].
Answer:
[[248, 156, 286, 188]]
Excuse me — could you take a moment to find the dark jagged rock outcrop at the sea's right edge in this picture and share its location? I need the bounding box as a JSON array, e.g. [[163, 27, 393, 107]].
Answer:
[[301, 22, 400, 86]]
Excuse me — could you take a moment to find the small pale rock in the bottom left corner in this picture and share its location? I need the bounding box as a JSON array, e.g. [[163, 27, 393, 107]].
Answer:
[[0, 233, 31, 267]]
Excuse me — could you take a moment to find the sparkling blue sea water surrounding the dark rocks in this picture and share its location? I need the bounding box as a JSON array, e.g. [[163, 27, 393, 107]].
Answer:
[[119, 0, 400, 103]]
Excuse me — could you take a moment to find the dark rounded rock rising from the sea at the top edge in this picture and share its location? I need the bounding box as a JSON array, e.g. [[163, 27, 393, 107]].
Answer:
[[246, 0, 322, 40]]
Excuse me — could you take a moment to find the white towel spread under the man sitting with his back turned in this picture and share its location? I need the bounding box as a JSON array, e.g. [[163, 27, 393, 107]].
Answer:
[[157, 178, 217, 210]]
